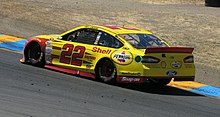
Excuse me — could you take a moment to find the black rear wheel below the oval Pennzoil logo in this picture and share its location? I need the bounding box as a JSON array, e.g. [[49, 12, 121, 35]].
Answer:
[[96, 59, 117, 84]]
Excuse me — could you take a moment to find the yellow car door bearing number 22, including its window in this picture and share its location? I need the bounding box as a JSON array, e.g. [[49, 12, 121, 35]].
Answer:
[[46, 29, 98, 70]]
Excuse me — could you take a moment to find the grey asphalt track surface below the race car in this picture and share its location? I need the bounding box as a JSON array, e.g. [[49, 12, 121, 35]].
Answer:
[[0, 50, 220, 117]]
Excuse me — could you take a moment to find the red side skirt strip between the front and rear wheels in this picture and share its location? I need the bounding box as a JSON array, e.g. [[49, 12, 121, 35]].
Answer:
[[45, 65, 96, 79]]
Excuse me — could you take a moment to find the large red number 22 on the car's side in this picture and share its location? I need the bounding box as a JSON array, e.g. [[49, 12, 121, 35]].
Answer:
[[60, 44, 86, 66]]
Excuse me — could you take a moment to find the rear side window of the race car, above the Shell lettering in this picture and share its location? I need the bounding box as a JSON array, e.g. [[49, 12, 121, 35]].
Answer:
[[97, 32, 123, 48]]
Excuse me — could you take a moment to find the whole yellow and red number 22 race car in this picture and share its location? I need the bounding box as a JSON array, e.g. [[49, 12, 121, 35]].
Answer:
[[21, 25, 195, 86]]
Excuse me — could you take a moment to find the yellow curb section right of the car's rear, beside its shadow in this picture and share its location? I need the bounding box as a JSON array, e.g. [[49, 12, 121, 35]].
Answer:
[[168, 81, 208, 90]]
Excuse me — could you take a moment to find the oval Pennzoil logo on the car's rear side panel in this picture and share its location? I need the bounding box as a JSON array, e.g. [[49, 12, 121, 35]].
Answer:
[[111, 51, 133, 65]]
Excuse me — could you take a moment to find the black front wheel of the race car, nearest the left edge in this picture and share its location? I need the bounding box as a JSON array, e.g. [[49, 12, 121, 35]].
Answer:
[[26, 43, 45, 67]]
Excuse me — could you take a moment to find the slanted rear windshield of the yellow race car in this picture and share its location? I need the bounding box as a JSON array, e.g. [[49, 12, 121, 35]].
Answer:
[[119, 34, 167, 49]]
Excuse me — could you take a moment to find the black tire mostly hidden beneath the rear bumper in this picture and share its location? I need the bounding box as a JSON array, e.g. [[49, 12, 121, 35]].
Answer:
[[150, 78, 172, 87]]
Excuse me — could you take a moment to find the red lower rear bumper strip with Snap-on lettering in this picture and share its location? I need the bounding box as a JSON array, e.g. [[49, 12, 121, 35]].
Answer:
[[117, 76, 195, 83]]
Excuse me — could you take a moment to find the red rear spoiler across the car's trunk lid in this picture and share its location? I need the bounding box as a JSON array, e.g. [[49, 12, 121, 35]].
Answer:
[[145, 47, 194, 54]]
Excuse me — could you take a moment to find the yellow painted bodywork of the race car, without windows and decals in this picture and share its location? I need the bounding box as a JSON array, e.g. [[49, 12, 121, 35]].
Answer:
[[35, 25, 195, 78]]
